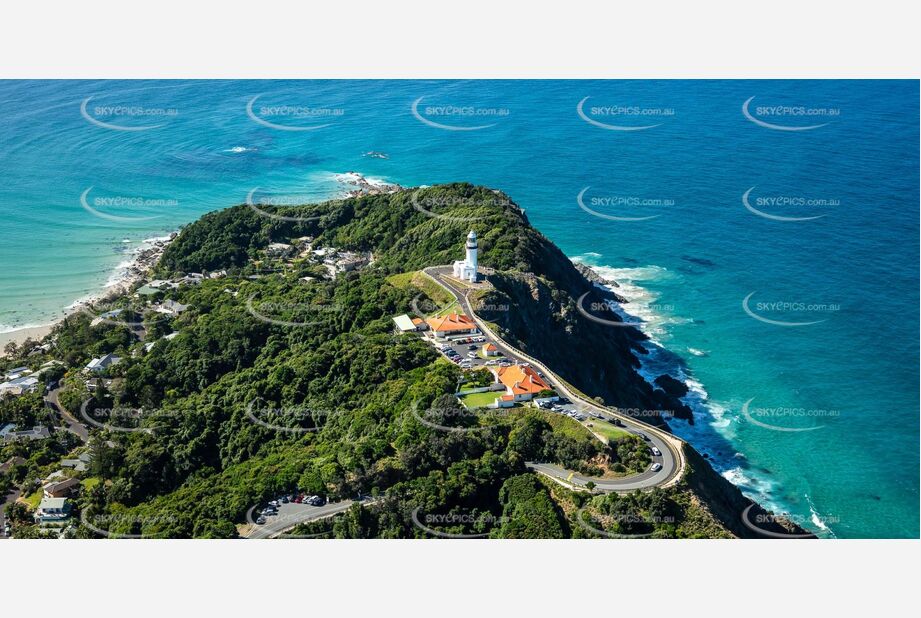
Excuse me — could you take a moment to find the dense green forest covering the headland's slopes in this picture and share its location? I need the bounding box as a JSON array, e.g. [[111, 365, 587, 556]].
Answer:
[[0, 184, 722, 538]]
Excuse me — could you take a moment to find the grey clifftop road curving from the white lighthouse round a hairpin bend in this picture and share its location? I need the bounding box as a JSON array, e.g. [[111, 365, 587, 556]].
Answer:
[[423, 266, 685, 492]]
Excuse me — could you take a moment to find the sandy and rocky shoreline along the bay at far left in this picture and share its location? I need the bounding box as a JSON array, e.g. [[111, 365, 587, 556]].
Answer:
[[0, 232, 178, 359]]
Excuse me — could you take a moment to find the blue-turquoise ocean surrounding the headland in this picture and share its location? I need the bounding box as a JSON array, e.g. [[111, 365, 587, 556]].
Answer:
[[0, 81, 919, 537]]
